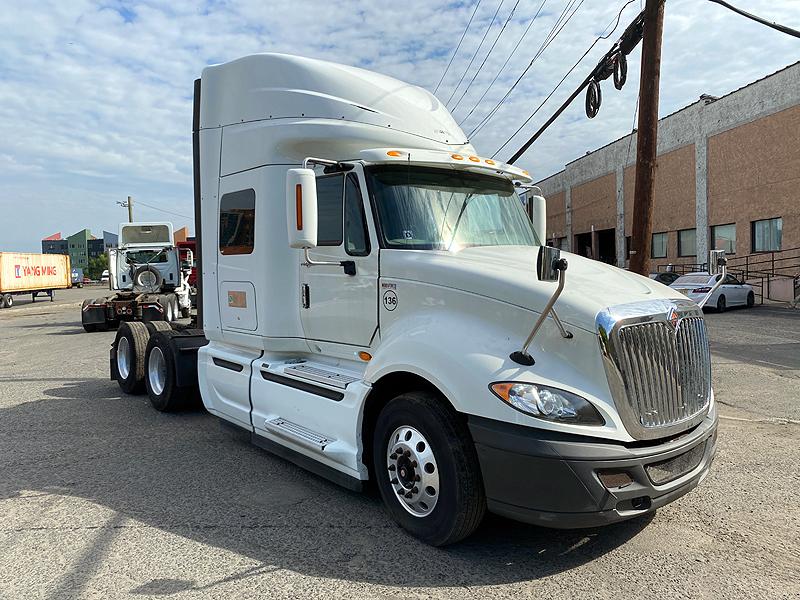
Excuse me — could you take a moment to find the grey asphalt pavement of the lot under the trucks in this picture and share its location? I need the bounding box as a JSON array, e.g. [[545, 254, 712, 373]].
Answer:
[[0, 288, 800, 600]]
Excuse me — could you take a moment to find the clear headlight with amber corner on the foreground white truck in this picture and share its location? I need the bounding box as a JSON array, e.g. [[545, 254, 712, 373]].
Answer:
[[489, 382, 605, 425]]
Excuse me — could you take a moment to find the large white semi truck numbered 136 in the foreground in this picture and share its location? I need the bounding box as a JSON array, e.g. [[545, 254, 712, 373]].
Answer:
[[111, 54, 717, 545]]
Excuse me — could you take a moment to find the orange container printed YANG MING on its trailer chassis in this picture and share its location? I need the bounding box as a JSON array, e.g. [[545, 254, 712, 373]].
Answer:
[[0, 252, 72, 308]]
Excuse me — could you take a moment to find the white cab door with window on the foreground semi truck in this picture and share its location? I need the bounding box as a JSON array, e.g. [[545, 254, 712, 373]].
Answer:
[[299, 167, 378, 347]]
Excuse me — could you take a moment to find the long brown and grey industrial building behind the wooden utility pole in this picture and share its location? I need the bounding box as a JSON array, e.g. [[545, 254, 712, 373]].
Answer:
[[537, 62, 800, 286]]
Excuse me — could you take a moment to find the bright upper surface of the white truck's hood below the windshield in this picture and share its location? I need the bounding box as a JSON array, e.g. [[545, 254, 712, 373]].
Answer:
[[381, 246, 686, 332]]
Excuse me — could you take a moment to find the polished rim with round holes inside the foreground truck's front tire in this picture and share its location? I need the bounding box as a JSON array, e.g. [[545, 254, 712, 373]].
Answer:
[[386, 425, 439, 517]]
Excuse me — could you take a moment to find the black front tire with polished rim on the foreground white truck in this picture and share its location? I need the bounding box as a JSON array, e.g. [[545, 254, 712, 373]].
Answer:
[[373, 392, 486, 546]]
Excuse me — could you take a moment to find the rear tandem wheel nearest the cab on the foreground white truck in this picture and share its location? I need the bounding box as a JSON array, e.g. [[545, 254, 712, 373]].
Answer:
[[145, 330, 194, 412]]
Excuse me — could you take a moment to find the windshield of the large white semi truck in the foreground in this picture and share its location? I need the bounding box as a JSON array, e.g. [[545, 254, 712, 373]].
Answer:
[[367, 165, 538, 250]]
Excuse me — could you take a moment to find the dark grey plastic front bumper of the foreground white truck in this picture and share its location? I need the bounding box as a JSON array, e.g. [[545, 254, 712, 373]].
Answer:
[[469, 409, 717, 529]]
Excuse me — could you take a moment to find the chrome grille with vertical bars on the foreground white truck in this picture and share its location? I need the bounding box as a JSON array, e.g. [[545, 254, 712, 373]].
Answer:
[[597, 300, 711, 439]]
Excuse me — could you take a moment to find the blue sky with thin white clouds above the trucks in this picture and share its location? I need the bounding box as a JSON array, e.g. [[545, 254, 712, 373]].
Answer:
[[0, 0, 800, 251]]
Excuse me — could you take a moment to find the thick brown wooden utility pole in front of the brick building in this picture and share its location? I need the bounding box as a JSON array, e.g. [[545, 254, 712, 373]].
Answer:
[[630, 0, 664, 276]]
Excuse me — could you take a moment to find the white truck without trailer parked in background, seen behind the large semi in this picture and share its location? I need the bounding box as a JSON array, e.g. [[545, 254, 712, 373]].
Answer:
[[81, 222, 191, 332]]
